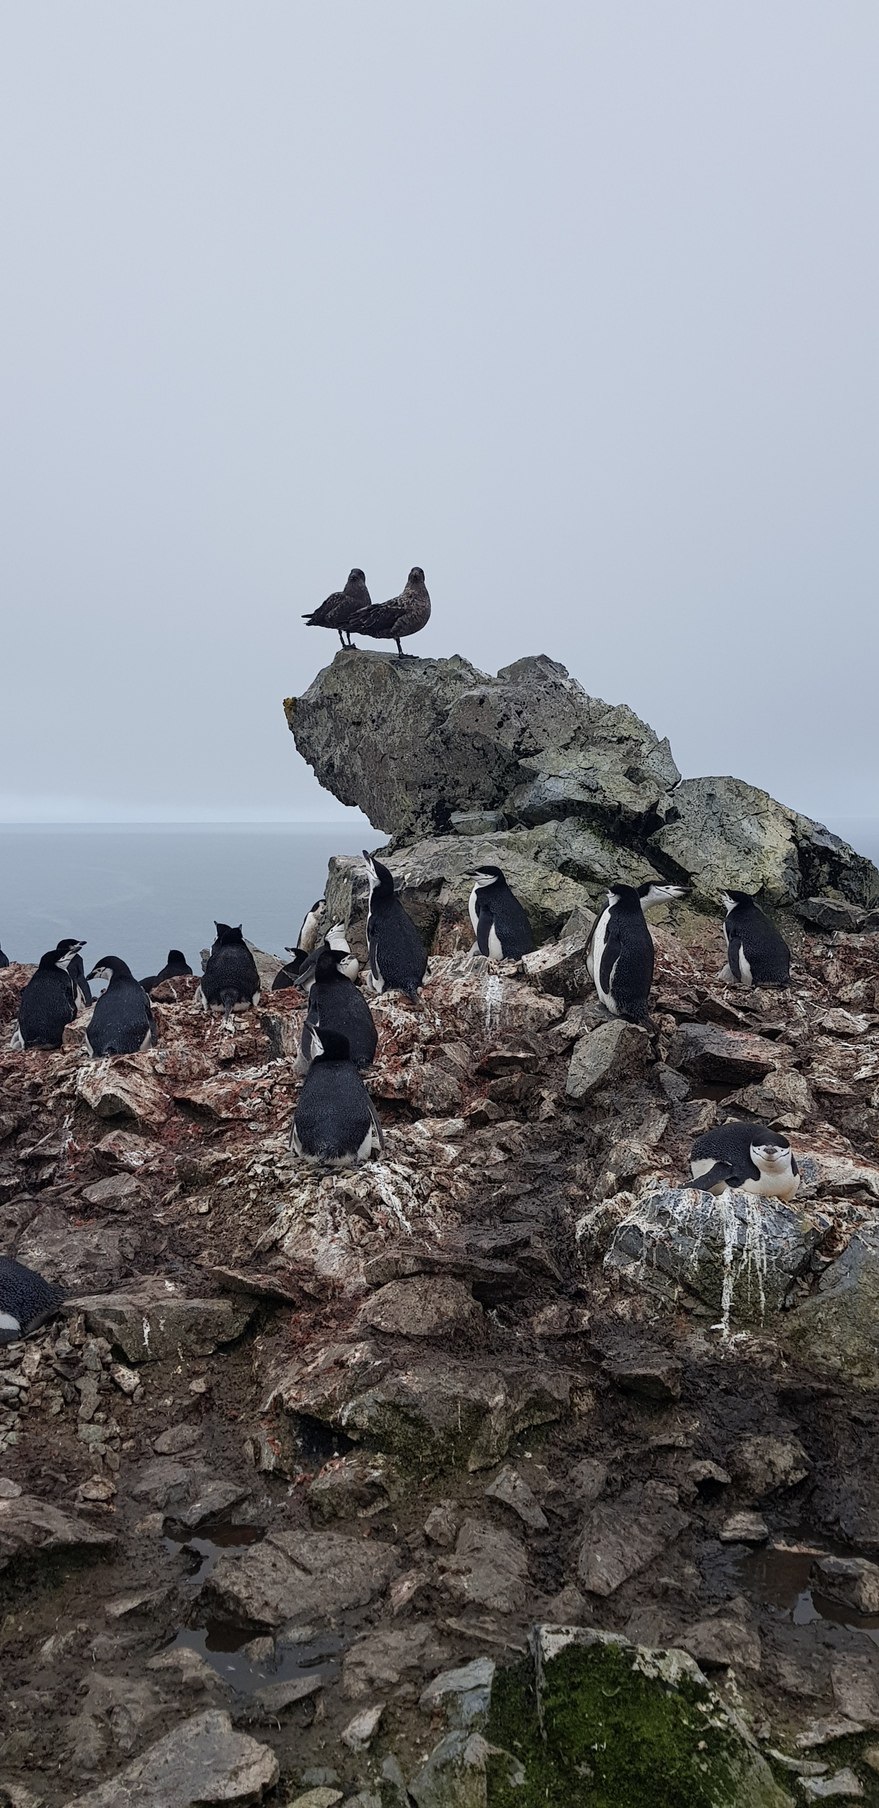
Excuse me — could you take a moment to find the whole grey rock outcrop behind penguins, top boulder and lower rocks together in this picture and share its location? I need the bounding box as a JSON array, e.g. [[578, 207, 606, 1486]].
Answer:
[[284, 649, 879, 911]]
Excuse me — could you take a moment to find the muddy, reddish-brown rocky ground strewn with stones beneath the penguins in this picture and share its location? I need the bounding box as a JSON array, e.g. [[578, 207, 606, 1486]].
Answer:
[[0, 911, 879, 1808]]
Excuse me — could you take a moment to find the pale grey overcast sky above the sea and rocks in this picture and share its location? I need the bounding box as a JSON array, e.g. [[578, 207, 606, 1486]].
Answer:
[[0, 0, 879, 819]]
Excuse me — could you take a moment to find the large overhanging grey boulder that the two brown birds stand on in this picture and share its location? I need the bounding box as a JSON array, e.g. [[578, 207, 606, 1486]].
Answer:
[[284, 651, 680, 839]]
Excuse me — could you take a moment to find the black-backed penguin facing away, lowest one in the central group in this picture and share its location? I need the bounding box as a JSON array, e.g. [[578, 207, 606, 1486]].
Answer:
[[289, 1031, 382, 1168]]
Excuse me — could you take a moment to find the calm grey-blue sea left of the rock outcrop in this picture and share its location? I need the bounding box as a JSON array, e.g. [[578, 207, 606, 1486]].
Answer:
[[0, 823, 367, 978]]
